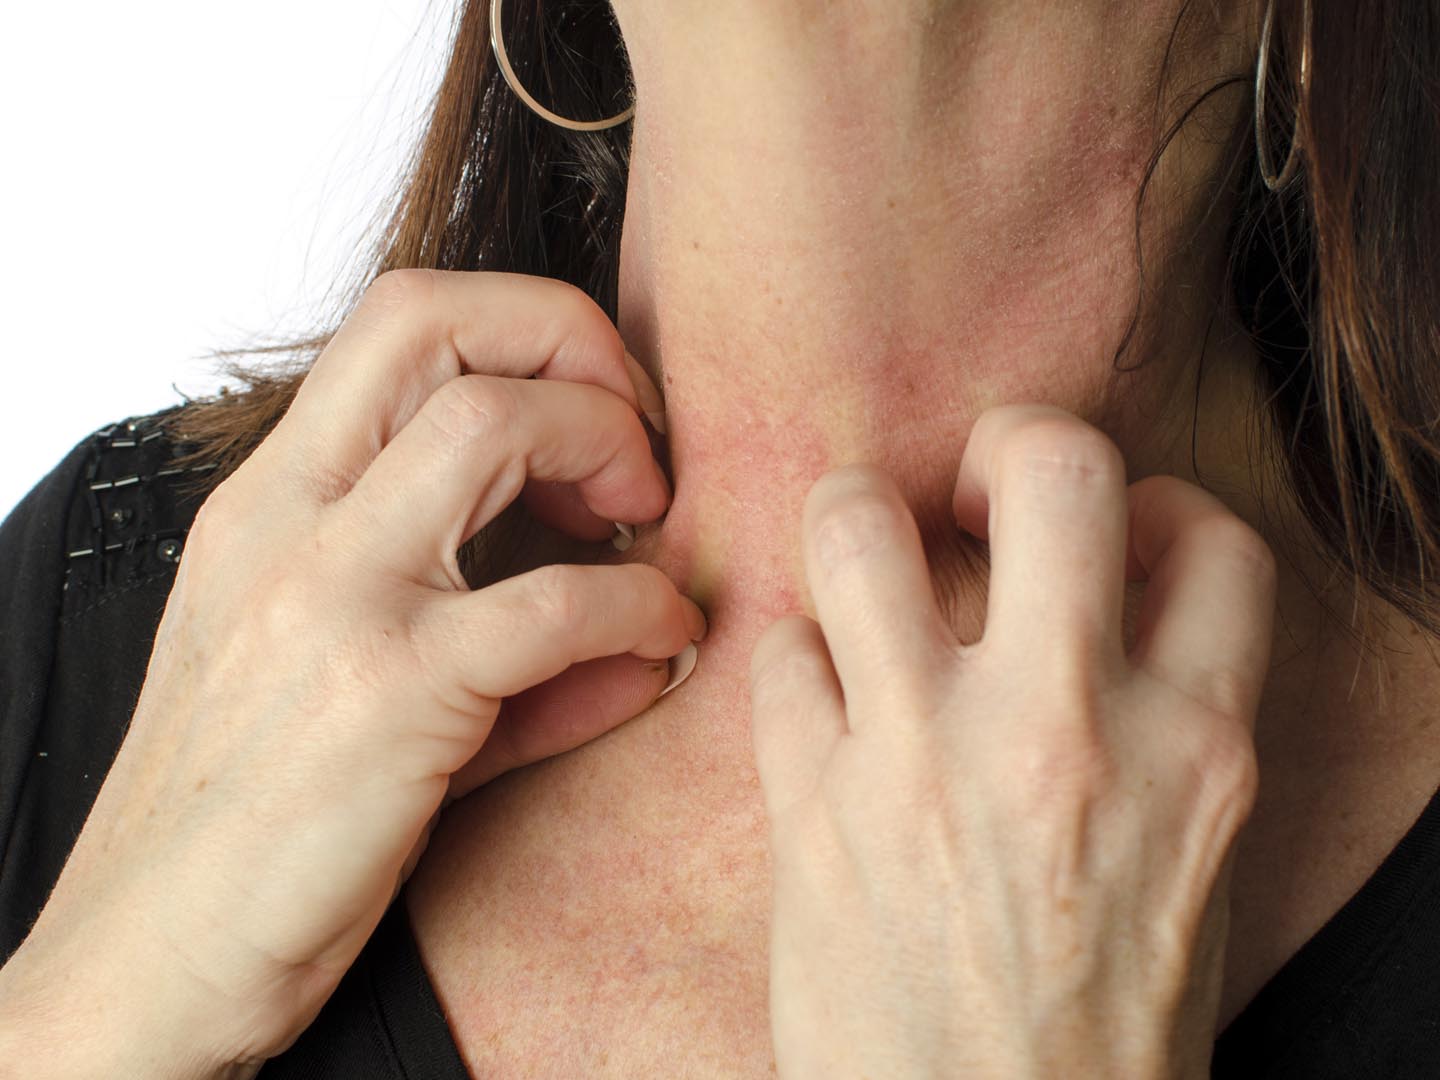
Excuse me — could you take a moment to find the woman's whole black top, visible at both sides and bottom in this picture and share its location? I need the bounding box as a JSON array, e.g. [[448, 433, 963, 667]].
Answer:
[[0, 406, 1440, 1080]]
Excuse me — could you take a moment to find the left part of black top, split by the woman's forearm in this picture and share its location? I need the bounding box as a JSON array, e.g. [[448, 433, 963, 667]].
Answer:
[[0, 406, 468, 1080]]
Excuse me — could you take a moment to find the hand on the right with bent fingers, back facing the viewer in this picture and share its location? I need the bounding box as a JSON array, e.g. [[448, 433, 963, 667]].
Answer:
[[750, 405, 1276, 1080]]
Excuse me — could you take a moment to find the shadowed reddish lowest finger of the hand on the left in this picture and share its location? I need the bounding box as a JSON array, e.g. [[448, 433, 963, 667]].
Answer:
[[449, 652, 670, 799]]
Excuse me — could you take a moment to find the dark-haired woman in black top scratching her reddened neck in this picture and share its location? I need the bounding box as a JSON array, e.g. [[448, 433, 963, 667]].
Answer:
[[0, 0, 1440, 1077]]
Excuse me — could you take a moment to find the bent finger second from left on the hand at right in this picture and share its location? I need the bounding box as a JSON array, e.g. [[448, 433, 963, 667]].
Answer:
[[802, 465, 956, 730]]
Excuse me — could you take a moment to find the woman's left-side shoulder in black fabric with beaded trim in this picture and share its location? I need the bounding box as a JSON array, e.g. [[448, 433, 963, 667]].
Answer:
[[0, 405, 206, 962]]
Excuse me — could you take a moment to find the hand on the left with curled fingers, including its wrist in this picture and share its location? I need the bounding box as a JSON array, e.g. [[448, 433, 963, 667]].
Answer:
[[0, 269, 704, 1077]]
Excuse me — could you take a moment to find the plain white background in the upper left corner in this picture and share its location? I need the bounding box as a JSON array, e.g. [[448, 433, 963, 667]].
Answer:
[[0, 0, 458, 518]]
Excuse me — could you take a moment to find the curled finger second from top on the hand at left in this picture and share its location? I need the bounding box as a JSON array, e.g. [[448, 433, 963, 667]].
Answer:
[[325, 374, 670, 588]]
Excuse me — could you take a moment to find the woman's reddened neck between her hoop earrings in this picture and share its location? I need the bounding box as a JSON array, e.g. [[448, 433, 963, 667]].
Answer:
[[604, 0, 1253, 625]]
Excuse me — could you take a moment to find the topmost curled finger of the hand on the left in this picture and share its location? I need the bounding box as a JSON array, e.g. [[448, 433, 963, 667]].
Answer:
[[271, 269, 641, 503]]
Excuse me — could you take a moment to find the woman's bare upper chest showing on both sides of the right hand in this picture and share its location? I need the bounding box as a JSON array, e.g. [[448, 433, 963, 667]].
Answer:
[[406, 673, 1440, 1080]]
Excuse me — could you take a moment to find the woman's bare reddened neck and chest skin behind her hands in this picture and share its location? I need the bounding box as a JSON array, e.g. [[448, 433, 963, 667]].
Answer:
[[408, 0, 1440, 1076]]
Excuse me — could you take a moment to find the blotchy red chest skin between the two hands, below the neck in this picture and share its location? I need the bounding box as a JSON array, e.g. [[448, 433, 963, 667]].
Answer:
[[406, 708, 775, 1080]]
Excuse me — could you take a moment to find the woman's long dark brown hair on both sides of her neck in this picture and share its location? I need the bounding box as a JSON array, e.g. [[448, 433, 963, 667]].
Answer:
[[170, 0, 1440, 635]]
